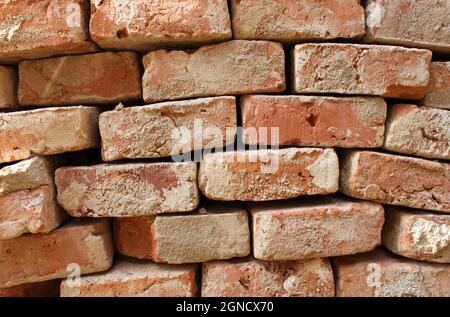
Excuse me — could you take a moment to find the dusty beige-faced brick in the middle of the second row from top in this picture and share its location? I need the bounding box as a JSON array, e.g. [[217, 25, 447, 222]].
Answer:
[[142, 41, 286, 102]]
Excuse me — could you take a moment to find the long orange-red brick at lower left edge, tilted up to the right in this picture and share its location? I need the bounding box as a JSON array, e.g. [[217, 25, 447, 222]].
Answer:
[[0, 219, 113, 288]]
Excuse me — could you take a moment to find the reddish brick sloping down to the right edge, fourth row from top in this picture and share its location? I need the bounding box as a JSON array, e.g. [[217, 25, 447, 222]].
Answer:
[[340, 151, 450, 212]]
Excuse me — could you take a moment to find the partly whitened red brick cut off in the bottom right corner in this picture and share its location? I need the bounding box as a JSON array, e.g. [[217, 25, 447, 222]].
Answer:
[[333, 249, 450, 297]]
